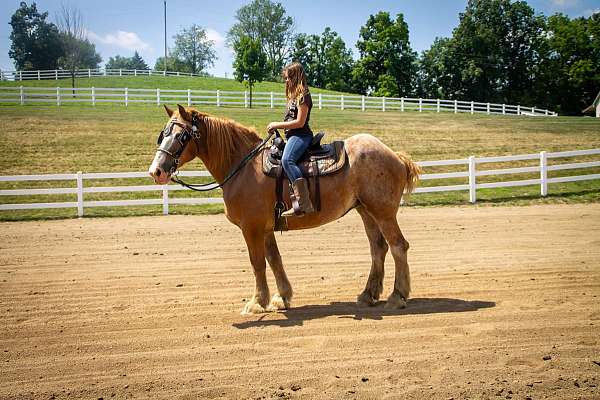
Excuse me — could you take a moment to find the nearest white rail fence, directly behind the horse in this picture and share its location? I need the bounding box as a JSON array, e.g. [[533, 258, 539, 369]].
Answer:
[[0, 149, 600, 216]]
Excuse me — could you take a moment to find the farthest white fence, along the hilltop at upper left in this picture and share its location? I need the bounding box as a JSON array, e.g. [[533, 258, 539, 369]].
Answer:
[[0, 68, 205, 81]]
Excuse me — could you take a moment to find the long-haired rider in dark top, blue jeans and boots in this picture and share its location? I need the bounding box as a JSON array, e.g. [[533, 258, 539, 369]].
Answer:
[[267, 62, 314, 217]]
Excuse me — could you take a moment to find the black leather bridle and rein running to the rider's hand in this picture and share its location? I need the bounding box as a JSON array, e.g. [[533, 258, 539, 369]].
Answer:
[[156, 115, 279, 192]]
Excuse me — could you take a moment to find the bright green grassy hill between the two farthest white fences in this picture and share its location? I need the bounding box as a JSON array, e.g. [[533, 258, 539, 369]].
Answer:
[[0, 76, 346, 94]]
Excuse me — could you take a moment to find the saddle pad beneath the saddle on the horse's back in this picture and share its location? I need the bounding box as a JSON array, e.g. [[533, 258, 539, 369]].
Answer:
[[262, 141, 346, 178]]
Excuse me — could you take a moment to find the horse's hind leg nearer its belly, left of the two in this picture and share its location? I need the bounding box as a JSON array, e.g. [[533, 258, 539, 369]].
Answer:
[[356, 207, 389, 306]]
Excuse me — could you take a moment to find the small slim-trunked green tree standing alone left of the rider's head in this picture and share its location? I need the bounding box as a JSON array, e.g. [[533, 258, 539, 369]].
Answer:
[[233, 36, 268, 108]]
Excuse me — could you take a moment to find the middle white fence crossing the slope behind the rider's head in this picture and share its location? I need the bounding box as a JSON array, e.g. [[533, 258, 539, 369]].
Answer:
[[0, 86, 558, 117]]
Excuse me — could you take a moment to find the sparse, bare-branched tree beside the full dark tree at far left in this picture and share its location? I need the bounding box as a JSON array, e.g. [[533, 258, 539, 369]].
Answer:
[[58, 5, 102, 88]]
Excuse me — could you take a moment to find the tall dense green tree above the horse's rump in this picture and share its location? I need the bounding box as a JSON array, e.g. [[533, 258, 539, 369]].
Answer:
[[352, 12, 416, 96]]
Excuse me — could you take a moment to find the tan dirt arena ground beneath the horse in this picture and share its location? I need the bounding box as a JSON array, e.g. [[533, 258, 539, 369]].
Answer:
[[0, 204, 600, 399]]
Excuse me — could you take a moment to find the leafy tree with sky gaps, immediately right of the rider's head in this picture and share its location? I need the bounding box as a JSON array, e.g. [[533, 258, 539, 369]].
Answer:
[[291, 27, 353, 91]]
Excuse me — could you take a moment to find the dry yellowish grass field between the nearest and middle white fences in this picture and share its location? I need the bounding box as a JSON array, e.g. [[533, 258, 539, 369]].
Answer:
[[0, 101, 600, 220]]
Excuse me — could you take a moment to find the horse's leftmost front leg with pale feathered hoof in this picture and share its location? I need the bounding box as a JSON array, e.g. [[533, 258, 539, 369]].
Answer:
[[242, 229, 269, 314]]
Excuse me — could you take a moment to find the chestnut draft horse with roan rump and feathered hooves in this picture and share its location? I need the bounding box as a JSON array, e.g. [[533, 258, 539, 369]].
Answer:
[[149, 106, 420, 314]]
